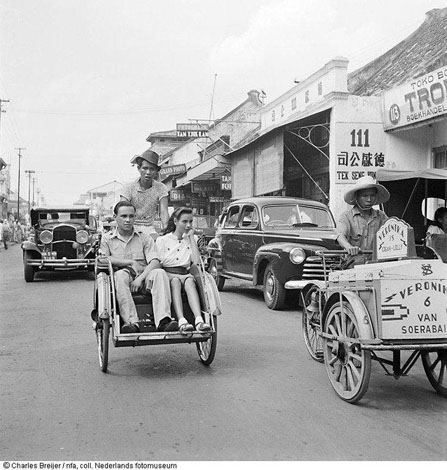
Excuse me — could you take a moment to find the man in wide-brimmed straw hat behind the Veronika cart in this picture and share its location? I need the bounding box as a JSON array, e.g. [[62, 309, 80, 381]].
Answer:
[[337, 176, 390, 267]]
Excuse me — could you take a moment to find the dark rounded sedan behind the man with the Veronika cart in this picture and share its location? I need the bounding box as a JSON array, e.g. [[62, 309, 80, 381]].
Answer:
[[208, 196, 340, 310]]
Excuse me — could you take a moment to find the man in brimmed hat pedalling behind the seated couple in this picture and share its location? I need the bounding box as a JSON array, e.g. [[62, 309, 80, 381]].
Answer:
[[121, 150, 169, 234]]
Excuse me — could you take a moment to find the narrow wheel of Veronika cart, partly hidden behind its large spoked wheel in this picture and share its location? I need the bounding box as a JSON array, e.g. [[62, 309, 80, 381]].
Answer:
[[301, 286, 324, 362]]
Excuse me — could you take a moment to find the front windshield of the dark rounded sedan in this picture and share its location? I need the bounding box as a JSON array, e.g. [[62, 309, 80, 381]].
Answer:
[[262, 204, 334, 229]]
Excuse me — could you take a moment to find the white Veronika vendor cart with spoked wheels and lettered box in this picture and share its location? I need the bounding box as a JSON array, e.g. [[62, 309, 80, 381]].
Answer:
[[290, 217, 447, 403]]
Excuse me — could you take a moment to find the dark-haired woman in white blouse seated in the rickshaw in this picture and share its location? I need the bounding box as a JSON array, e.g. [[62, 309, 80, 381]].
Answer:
[[155, 207, 211, 333]]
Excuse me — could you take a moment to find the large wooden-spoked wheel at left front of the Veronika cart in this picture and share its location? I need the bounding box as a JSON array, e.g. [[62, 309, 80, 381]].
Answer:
[[323, 302, 371, 403]]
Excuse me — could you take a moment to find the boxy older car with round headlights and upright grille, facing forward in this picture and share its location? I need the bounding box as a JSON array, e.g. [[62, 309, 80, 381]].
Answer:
[[22, 206, 99, 282]]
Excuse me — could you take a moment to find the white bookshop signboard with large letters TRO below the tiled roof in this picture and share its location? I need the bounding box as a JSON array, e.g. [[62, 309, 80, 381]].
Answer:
[[383, 66, 447, 130]]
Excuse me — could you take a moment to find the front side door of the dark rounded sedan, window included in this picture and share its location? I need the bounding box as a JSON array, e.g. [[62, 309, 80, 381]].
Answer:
[[233, 204, 262, 276]]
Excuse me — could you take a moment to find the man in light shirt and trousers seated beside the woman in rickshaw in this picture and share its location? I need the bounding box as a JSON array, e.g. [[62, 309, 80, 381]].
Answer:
[[100, 201, 178, 333]]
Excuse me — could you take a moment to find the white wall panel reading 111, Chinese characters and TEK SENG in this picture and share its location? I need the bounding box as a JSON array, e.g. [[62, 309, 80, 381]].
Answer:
[[335, 122, 386, 184]]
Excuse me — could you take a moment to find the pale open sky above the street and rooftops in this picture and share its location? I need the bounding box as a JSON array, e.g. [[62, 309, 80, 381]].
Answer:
[[0, 0, 447, 204]]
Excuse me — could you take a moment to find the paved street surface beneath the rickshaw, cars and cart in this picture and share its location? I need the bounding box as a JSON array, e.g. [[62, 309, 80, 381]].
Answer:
[[0, 245, 447, 460]]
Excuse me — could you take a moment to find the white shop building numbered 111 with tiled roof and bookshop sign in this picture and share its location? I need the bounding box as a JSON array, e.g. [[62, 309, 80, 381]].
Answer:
[[226, 9, 447, 223]]
